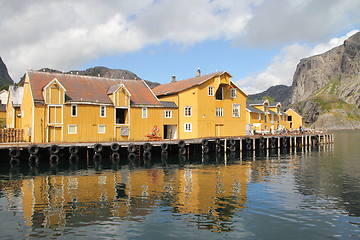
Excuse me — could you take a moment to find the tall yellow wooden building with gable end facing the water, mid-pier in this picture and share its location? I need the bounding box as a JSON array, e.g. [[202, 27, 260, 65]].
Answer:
[[153, 71, 247, 139]]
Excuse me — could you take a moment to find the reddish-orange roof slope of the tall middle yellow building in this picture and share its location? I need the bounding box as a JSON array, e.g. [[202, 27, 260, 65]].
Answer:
[[152, 71, 231, 96]]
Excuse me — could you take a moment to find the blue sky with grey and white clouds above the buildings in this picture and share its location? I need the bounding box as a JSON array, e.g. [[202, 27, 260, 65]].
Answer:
[[0, 0, 360, 94]]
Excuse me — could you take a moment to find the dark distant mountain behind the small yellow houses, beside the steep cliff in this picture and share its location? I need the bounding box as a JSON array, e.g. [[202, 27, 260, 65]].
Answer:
[[248, 85, 291, 103]]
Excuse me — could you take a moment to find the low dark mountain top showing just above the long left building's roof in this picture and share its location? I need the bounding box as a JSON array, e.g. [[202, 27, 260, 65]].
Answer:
[[39, 67, 160, 88]]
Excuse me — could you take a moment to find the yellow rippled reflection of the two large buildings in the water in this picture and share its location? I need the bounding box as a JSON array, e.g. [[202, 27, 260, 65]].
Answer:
[[0, 153, 249, 231]]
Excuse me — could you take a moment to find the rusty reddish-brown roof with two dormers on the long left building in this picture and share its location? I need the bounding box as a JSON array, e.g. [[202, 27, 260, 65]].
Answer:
[[27, 71, 161, 106]]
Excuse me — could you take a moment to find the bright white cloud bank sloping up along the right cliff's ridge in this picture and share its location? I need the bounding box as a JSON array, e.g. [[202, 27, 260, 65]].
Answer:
[[236, 30, 358, 94]]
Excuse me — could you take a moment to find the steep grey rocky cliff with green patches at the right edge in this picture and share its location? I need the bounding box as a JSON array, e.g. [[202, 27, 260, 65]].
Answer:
[[285, 32, 360, 129]]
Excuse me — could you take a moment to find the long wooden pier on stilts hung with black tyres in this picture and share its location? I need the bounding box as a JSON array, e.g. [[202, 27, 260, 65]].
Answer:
[[0, 133, 334, 164]]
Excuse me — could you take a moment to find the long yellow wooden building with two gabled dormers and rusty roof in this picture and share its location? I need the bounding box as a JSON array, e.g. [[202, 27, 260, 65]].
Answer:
[[14, 71, 177, 143]]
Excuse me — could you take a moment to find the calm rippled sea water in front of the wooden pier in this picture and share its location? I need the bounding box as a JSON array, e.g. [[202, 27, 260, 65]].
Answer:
[[0, 131, 360, 239]]
